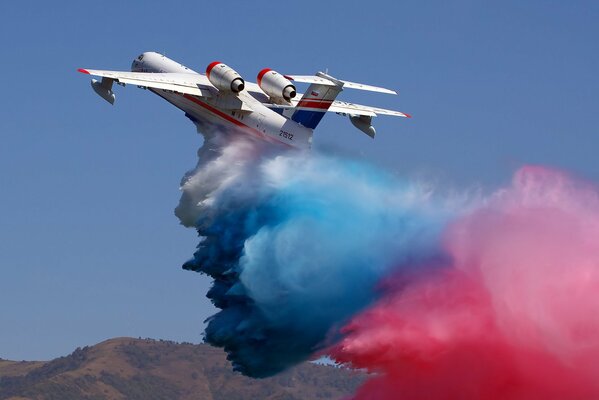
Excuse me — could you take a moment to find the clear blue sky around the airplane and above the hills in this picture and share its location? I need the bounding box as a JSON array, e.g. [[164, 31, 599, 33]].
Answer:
[[0, 0, 599, 360]]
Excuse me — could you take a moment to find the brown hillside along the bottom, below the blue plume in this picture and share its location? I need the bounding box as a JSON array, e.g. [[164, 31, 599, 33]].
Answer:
[[0, 338, 363, 400]]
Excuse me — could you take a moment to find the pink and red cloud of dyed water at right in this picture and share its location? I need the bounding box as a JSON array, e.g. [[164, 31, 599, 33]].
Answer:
[[330, 167, 599, 399]]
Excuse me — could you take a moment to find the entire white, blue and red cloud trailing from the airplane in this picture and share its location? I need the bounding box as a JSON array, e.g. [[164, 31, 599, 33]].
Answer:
[[176, 134, 599, 399]]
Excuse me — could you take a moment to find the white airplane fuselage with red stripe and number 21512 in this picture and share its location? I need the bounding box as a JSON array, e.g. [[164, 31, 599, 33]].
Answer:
[[131, 52, 313, 149]]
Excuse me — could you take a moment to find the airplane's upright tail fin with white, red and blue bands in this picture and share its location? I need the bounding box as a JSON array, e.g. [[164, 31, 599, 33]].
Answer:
[[291, 72, 343, 129]]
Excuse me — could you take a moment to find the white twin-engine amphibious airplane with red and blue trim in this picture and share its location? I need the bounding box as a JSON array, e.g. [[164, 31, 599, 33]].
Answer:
[[78, 52, 411, 149]]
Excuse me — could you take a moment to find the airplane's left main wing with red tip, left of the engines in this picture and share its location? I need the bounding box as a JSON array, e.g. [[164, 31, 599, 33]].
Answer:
[[78, 68, 217, 97]]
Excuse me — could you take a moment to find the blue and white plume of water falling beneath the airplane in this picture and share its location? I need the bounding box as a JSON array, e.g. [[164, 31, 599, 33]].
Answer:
[[176, 135, 448, 377]]
